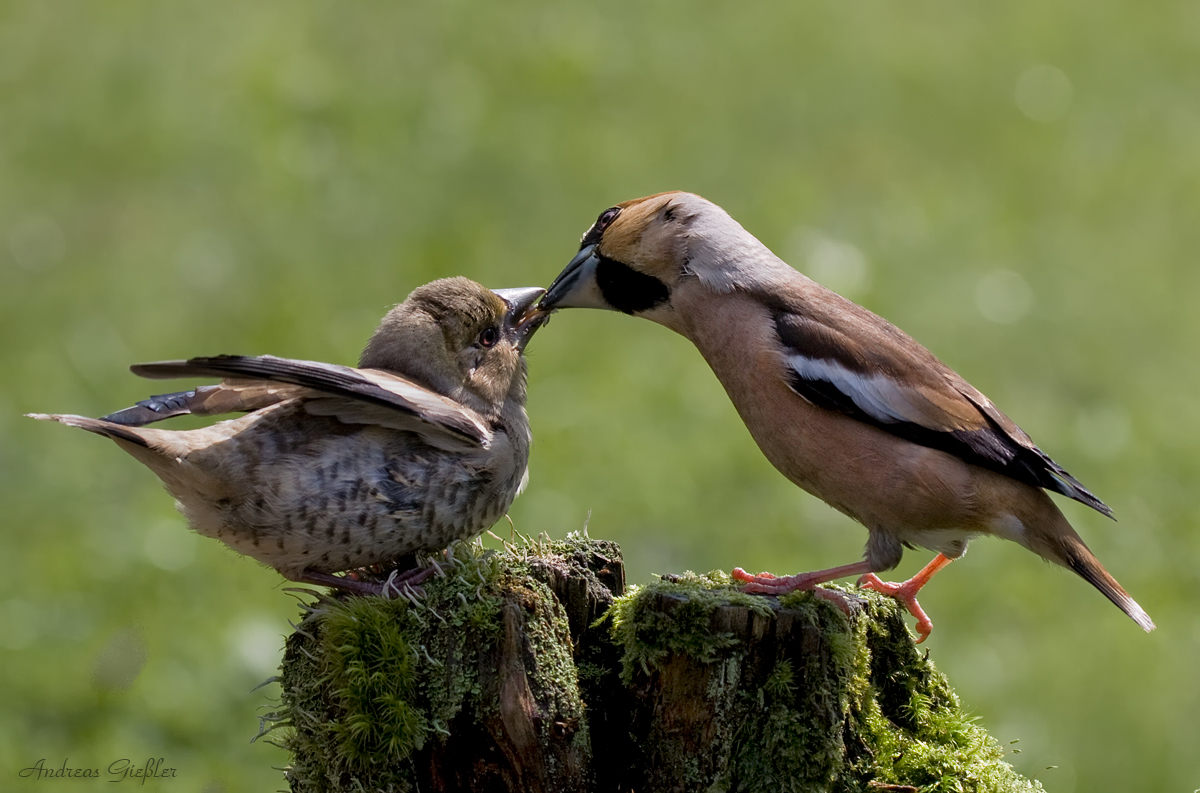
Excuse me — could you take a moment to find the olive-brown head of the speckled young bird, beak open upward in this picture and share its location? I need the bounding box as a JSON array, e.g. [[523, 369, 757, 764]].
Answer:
[[359, 277, 548, 414]]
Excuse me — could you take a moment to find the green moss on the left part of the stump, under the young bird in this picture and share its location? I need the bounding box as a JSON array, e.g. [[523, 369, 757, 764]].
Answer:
[[278, 535, 593, 793]]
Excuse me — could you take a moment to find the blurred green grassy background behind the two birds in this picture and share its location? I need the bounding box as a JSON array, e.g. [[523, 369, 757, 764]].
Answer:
[[0, 0, 1200, 793]]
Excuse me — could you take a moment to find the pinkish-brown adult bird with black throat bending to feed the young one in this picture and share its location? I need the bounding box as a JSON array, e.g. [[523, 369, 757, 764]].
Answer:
[[541, 192, 1154, 641]]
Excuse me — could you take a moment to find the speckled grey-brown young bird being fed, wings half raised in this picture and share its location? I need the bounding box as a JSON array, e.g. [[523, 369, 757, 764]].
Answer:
[[30, 278, 546, 593]]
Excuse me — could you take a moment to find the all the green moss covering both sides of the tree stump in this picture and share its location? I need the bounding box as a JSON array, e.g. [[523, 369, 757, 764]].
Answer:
[[276, 536, 1042, 793]]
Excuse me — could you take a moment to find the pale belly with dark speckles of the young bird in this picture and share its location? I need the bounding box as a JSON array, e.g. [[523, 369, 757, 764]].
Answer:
[[169, 407, 526, 577]]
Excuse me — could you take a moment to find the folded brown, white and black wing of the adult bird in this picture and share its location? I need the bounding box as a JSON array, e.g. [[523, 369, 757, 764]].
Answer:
[[773, 288, 1112, 517]]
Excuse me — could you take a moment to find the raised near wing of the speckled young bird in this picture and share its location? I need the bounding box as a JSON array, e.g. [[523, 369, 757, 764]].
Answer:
[[130, 355, 492, 449]]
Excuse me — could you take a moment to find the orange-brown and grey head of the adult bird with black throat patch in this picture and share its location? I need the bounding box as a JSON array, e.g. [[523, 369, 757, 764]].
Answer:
[[540, 192, 787, 324]]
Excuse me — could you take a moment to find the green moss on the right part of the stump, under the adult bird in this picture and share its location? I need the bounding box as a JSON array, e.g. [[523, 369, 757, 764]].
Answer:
[[611, 572, 1042, 793]]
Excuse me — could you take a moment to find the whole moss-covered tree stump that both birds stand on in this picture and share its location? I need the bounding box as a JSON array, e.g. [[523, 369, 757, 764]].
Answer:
[[275, 536, 1040, 793]]
